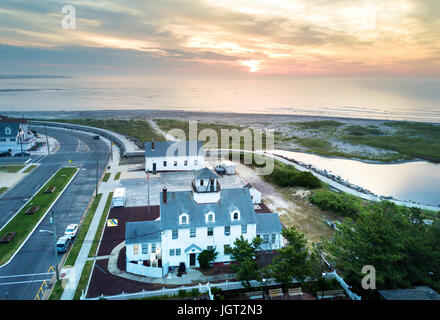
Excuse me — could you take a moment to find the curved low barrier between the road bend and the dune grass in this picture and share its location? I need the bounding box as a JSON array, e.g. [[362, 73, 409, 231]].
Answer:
[[29, 120, 144, 157]]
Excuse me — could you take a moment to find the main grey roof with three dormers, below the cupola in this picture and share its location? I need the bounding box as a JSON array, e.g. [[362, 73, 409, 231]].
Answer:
[[160, 188, 257, 229]]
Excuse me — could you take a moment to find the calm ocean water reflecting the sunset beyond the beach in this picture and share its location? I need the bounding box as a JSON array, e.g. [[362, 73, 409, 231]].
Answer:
[[0, 76, 440, 123]]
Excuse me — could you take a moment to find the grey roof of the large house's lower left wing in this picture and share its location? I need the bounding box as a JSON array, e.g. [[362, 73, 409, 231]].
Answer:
[[125, 220, 161, 244]]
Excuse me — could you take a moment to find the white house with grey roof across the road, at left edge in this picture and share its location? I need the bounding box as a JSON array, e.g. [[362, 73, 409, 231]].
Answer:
[[0, 117, 37, 152]]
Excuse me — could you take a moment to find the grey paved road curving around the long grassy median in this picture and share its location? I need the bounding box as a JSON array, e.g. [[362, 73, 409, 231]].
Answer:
[[0, 128, 110, 300]]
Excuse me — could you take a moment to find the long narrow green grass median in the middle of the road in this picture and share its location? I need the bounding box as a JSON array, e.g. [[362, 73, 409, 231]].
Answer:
[[0, 168, 78, 265]]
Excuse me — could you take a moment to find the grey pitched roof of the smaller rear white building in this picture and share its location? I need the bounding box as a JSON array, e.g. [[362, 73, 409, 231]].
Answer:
[[145, 141, 203, 158]]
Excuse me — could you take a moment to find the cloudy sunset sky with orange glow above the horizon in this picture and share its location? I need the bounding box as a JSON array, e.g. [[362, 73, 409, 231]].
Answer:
[[0, 0, 440, 78]]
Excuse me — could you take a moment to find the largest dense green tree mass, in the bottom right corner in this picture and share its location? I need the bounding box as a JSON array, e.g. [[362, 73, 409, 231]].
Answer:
[[325, 201, 440, 297]]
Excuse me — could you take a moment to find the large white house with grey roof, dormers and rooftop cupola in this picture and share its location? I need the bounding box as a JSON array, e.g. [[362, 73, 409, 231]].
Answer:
[[126, 168, 282, 277]]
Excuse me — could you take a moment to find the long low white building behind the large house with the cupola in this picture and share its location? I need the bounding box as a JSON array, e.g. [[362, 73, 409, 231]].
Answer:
[[145, 141, 205, 173]]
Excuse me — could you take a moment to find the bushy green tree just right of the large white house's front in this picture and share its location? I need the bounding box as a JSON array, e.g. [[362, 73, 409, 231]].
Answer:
[[269, 226, 318, 290]]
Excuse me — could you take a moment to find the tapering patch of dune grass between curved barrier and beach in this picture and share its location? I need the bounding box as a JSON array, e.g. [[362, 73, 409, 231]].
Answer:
[[44, 119, 165, 144]]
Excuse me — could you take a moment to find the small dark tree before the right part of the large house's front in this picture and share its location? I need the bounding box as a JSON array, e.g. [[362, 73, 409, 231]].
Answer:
[[225, 236, 262, 290]]
